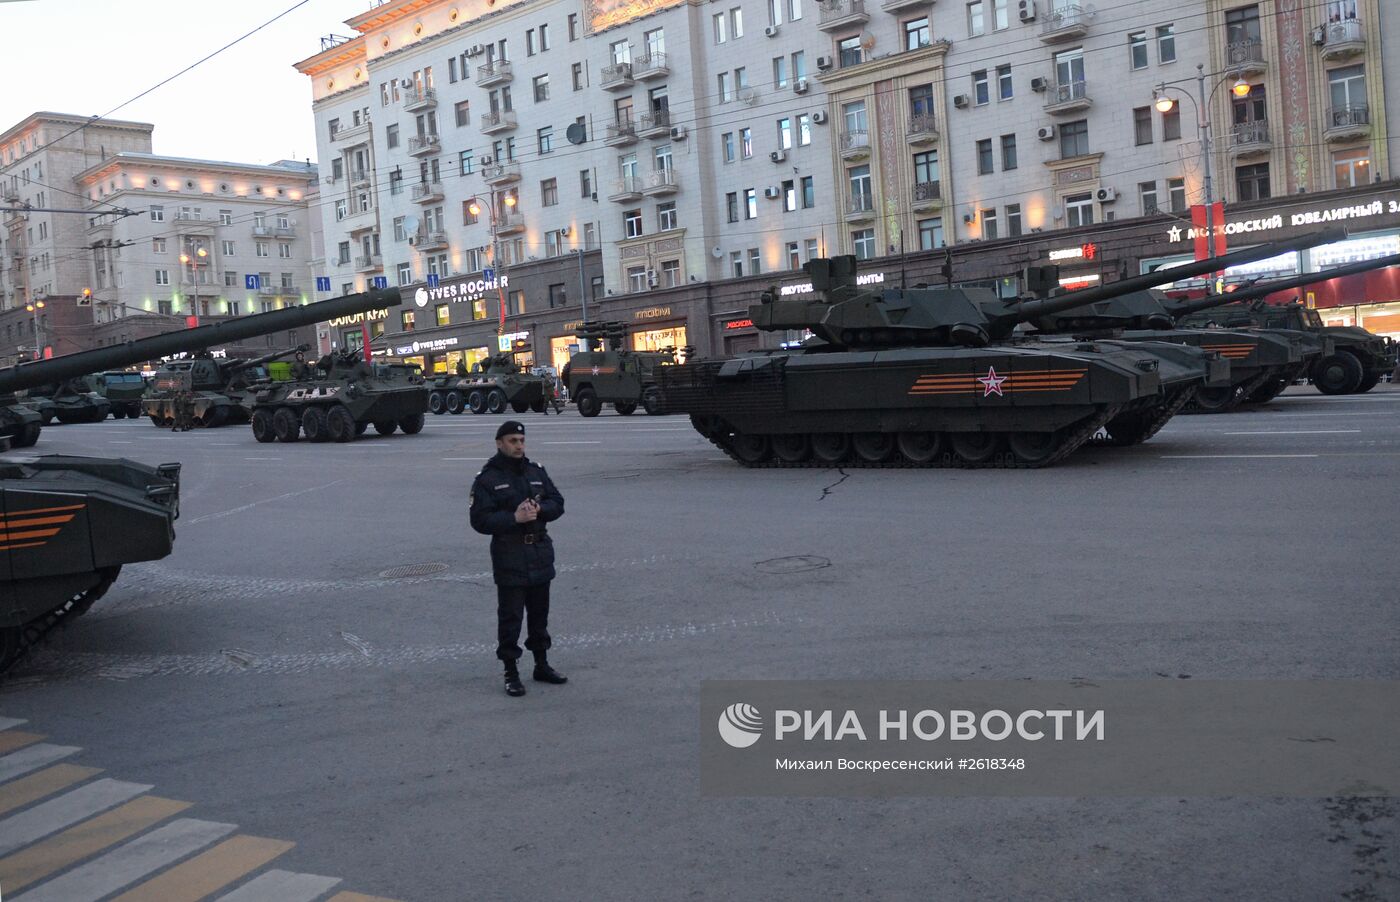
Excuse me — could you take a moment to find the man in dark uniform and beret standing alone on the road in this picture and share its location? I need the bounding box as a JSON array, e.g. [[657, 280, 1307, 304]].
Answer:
[[472, 420, 568, 696]]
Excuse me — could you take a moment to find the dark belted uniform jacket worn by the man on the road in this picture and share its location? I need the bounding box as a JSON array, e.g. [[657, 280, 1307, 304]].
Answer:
[[472, 452, 564, 585]]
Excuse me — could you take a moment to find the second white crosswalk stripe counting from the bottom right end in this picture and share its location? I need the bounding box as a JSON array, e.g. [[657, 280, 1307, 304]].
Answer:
[[15, 818, 237, 902]]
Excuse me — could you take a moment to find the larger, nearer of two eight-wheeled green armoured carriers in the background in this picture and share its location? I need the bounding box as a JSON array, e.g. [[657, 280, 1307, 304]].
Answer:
[[252, 350, 428, 443]]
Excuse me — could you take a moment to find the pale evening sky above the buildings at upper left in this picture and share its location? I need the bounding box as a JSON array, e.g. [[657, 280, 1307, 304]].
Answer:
[[0, 0, 371, 164]]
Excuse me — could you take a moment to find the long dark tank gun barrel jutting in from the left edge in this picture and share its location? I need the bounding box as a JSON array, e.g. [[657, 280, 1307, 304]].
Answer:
[[0, 289, 402, 394]]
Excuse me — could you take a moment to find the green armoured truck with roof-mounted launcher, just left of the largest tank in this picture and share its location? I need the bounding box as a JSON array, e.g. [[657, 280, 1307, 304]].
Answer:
[[560, 322, 676, 416]]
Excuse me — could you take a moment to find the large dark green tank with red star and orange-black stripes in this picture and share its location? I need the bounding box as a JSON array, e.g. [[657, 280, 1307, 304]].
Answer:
[[658, 231, 1344, 466]]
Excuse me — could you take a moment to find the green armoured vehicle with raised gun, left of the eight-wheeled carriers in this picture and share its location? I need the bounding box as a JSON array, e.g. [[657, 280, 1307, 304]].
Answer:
[[141, 345, 307, 429]]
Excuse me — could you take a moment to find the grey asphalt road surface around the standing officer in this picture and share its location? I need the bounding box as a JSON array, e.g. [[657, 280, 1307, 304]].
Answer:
[[0, 385, 1400, 901]]
